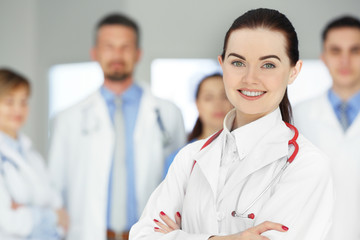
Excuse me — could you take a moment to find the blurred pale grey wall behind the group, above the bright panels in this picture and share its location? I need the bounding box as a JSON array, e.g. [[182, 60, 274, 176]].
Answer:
[[0, 0, 360, 156]]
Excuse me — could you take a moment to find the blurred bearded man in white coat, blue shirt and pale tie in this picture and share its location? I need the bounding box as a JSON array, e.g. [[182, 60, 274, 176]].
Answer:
[[49, 14, 185, 240]]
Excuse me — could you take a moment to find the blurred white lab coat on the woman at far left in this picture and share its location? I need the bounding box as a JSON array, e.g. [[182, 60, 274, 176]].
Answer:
[[0, 134, 62, 240]]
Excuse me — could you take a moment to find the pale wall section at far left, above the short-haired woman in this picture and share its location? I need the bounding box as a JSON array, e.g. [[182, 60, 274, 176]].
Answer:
[[0, 0, 38, 146]]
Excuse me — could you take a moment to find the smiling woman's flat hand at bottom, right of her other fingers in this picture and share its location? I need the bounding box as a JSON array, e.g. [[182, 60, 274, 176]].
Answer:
[[209, 221, 289, 240]]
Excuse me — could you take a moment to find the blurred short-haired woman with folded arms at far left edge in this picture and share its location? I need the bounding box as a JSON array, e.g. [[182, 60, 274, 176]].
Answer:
[[0, 69, 68, 240]]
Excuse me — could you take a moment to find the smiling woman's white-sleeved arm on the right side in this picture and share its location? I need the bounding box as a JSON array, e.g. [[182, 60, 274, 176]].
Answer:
[[255, 144, 334, 240]]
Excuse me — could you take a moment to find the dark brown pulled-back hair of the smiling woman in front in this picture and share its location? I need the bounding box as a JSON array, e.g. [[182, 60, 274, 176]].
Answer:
[[221, 8, 299, 123]]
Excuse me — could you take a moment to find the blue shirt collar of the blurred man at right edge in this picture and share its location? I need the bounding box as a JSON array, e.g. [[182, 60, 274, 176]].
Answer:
[[328, 89, 360, 126]]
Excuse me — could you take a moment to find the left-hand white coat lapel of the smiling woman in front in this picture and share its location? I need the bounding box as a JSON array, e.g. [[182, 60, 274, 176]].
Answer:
[[194, 132, 225, 199]]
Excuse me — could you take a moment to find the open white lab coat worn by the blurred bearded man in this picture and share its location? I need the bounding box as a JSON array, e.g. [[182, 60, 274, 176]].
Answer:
[[49, 82, 185, 240]]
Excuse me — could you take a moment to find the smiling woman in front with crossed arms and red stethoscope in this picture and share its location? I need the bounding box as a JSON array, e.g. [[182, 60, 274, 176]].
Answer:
[[130, 9, 333, 240]]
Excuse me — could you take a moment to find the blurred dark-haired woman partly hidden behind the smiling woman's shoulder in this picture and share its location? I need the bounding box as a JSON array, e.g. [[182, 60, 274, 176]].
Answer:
[[164, 73, 233, 177]]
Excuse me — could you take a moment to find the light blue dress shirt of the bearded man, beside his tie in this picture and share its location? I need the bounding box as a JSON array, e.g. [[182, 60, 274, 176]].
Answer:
[[100, 84, 142, 230]]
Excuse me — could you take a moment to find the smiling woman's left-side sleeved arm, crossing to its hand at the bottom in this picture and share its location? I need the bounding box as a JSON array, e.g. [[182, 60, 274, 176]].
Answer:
[[130, 143, 287, 240]]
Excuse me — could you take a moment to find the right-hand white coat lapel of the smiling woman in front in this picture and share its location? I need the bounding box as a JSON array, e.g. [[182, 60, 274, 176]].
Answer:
[[218, 122, 293, 201]]
